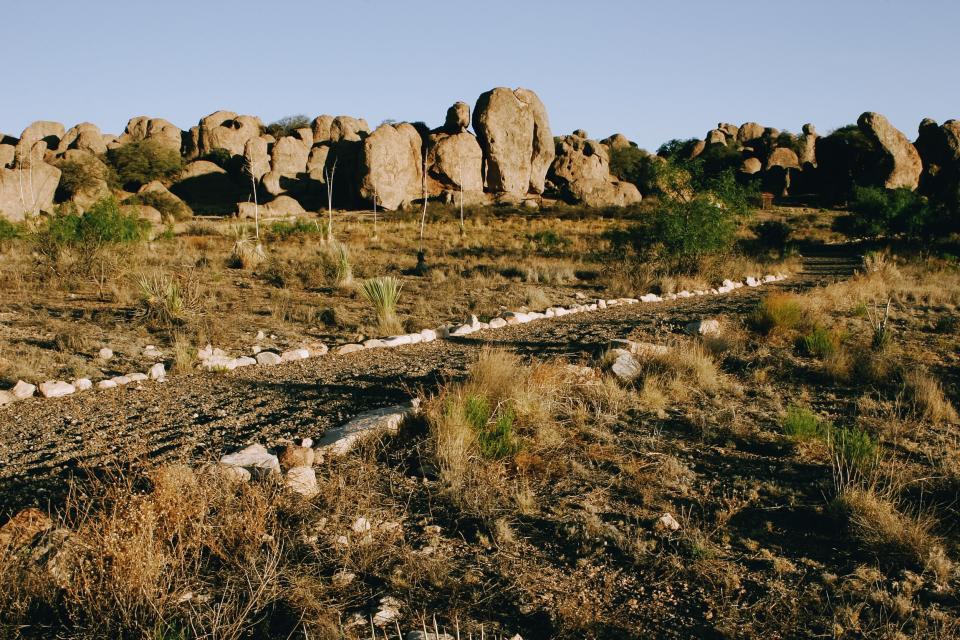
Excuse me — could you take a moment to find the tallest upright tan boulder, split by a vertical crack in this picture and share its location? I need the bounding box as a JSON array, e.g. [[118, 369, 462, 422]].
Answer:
[[473, 87, 555, 196]]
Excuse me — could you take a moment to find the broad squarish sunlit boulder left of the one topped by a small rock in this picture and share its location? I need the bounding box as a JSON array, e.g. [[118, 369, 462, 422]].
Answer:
[[359, 122, 423, 211]]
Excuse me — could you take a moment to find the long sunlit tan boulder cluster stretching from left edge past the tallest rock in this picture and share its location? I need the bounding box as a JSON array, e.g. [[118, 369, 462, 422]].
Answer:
[[0, 87, 640, 221]]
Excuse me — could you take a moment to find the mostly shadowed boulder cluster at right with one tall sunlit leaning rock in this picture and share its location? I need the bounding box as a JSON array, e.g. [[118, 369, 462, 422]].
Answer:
[[685, 111, 960, 200]]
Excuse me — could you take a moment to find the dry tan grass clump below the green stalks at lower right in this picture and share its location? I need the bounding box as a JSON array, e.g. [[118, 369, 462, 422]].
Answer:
[[834, 487, 953, 580]]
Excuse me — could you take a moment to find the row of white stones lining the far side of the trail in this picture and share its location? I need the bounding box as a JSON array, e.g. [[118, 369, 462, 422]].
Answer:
[[0, 273, 787, 407]]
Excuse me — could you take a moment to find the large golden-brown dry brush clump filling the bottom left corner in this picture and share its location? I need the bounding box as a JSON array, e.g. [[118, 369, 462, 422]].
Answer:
[[0, 466, 292, 638]]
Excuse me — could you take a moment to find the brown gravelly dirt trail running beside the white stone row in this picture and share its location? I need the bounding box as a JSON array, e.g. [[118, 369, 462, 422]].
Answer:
[[0, 247, 858, 518]]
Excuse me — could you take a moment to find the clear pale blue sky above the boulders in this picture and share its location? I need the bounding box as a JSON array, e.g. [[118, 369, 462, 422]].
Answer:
[[0, 0, 960, 149]]
